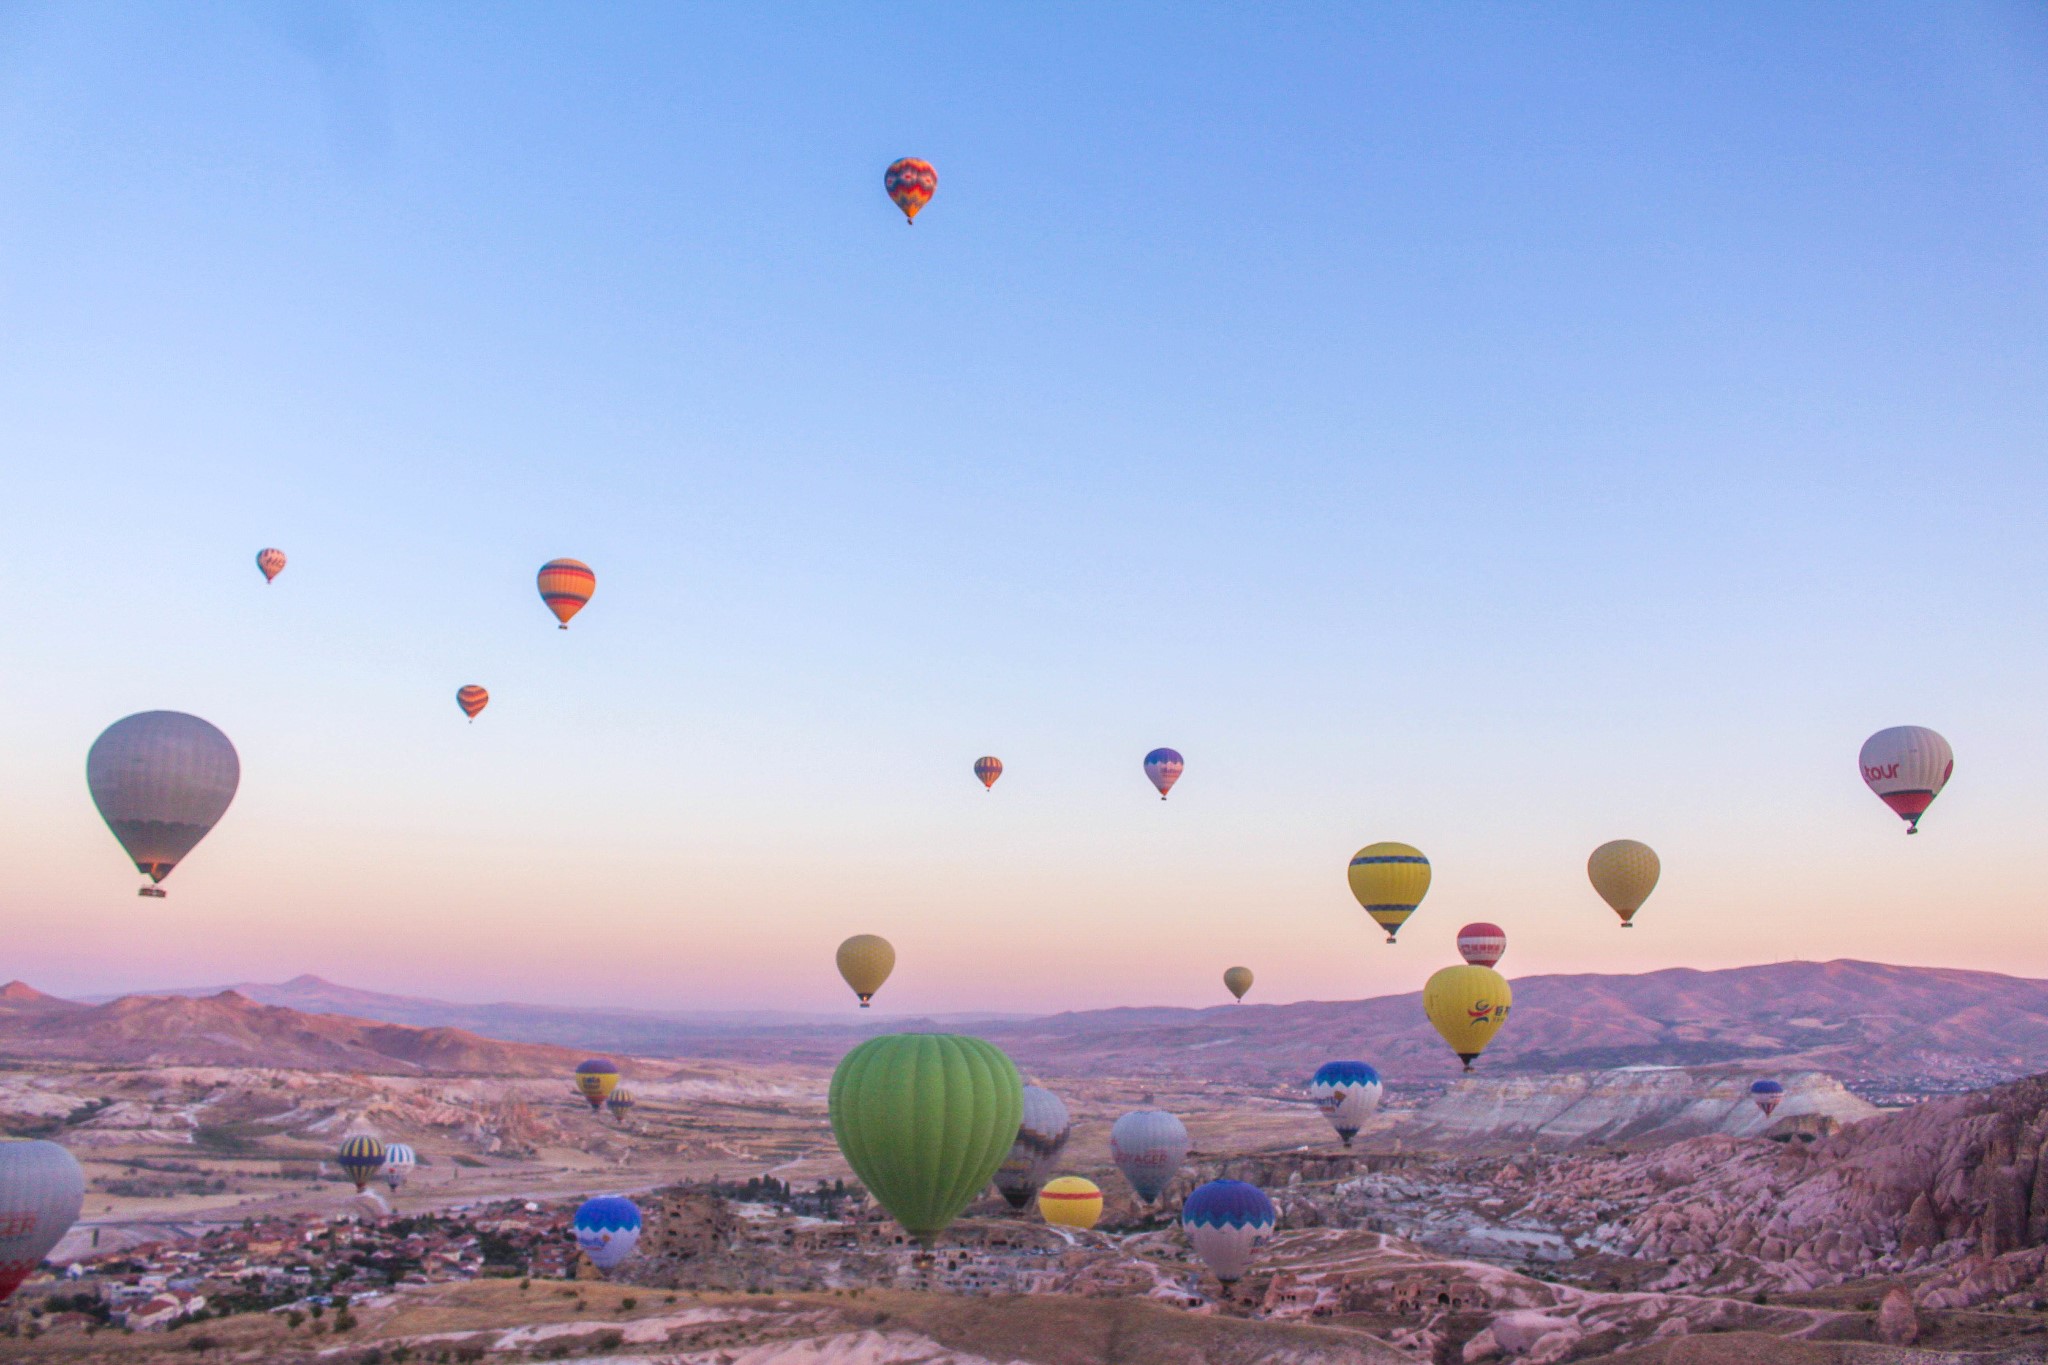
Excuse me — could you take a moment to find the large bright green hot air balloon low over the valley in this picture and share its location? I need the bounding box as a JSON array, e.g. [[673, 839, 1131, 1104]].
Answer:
[[827, 1033, 1024, 1246]]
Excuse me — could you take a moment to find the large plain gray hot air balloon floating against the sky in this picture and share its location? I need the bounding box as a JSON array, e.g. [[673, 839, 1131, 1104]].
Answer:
[[86, 710, 242, 896]]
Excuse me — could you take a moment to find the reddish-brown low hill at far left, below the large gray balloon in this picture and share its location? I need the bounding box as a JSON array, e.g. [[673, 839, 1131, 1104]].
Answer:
[[0, 990, 622, 1076]]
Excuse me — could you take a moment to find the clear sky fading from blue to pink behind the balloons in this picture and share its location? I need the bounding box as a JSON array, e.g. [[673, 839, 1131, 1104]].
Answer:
[[0, 2, 2048, 1011]]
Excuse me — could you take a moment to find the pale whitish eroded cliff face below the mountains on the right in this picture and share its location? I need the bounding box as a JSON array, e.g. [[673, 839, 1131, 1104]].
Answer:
[[1399, 1066, 1878, 1146]]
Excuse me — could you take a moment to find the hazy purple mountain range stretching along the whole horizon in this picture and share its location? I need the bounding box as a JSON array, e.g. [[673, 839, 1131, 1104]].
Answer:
[[16, 960, 2048, 1093]]
